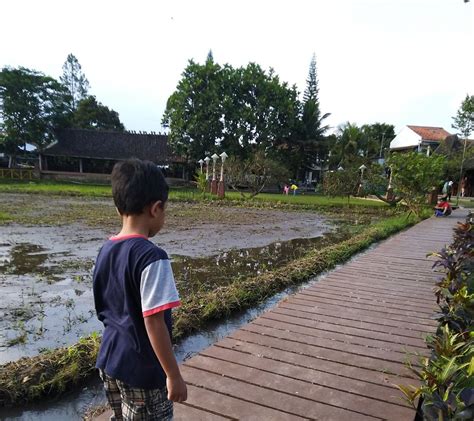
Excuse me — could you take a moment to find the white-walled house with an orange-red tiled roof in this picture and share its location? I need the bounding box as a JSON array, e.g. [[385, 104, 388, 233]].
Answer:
[[390, 125, 451, 154]]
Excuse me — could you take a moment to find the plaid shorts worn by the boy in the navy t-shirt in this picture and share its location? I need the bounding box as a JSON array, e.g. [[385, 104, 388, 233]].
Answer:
[[99, 370, 173, 421]]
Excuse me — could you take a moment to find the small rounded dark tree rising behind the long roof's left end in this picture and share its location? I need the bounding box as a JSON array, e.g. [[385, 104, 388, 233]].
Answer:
[[72, 95, 125, 131]]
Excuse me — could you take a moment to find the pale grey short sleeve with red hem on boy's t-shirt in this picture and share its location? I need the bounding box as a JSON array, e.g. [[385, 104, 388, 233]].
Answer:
[[140, 260, 179, 313]]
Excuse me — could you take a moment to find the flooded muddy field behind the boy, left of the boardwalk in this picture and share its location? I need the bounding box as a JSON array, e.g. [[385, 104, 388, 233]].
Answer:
[[0, 194, 345, 364]]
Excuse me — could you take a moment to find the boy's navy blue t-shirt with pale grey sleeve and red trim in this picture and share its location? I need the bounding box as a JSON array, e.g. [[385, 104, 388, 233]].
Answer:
[[93, 235, 180, 389]]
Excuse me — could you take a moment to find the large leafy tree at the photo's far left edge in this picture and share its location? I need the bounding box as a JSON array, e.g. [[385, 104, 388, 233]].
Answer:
[[0, 67, 70, 162]]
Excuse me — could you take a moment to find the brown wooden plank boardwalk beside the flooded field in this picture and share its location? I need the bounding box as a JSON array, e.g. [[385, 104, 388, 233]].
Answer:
[[95, 210, 465, 421]]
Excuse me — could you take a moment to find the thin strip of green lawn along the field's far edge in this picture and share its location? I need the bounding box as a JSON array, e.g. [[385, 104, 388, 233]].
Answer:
[[0, 180, 387, 207]]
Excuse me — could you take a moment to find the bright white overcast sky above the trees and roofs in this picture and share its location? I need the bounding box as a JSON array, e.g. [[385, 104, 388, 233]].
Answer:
[[0, 0, 474, 135]]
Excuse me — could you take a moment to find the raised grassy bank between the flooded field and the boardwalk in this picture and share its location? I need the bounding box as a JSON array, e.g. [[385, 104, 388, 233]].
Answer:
[[0, 215, 418, 407]]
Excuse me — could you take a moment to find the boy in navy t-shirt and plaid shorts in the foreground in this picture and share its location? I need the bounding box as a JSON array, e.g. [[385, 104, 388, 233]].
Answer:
[[93, 159, 187, 420]]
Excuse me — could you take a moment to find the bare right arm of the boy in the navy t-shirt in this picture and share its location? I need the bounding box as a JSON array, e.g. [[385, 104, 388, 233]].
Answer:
[[144, 311, 188, 402]]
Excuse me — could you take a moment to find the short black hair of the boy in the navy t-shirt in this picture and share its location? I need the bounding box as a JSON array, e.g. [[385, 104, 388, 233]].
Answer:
[[112, 159, 169, 215]]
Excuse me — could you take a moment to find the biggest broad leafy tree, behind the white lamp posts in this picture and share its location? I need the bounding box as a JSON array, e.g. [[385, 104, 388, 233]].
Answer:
[[162, 56, 299, 164]]
